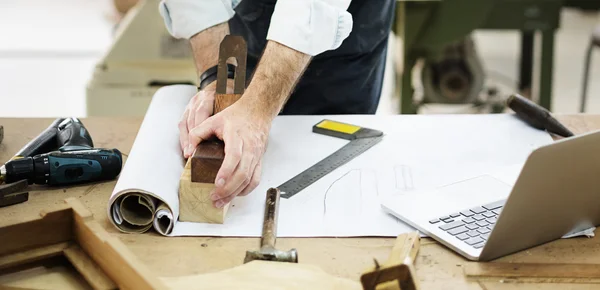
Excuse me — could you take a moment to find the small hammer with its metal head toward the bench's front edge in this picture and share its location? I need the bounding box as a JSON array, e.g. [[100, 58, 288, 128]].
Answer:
[[244, 188, 298, 264]]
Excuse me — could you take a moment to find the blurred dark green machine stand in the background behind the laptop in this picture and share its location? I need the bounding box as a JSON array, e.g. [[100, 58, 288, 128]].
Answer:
[[395, 0, 564, 114]]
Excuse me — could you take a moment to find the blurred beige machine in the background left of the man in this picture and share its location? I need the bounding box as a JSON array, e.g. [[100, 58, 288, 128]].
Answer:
[[86, 0, 198, 116]]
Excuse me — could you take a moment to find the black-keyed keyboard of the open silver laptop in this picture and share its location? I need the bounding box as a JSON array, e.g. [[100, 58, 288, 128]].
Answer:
[[429, 200, 506, 249]]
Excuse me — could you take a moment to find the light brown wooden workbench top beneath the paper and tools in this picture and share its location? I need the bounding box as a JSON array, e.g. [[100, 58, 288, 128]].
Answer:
[[0, 115, 600, 289]]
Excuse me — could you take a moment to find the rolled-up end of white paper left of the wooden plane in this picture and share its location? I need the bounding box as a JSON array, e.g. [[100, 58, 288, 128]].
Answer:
[[107, 85, 197, 235]]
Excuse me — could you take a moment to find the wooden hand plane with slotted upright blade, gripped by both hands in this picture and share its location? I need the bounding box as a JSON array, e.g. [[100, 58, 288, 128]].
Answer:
[[179, 35, 247, 224]]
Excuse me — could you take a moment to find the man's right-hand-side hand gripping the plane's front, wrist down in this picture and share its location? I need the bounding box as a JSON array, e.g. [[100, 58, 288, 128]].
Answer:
[[185, 97, 271, 208]]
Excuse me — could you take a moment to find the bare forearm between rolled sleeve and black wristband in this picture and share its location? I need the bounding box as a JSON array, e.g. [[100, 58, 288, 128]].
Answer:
[[190, 22, 229, 76]]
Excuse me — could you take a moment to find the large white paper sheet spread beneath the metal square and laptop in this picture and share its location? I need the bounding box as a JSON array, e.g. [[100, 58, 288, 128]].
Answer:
[[109, 86, 552, 237]]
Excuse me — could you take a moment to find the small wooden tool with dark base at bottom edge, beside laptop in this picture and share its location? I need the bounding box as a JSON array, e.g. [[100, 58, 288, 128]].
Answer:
[[360, 231, 420, 290]]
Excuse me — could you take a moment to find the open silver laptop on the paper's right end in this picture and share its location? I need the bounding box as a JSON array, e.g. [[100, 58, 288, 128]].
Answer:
[[382, 131, 600, 261]]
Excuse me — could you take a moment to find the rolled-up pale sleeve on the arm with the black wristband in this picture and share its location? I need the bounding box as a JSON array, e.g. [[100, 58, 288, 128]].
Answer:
[[159, 0, 234, 39]]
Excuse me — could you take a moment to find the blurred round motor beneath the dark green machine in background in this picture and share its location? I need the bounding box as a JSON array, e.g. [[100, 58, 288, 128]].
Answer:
[[421, 36, 485, 104]]
